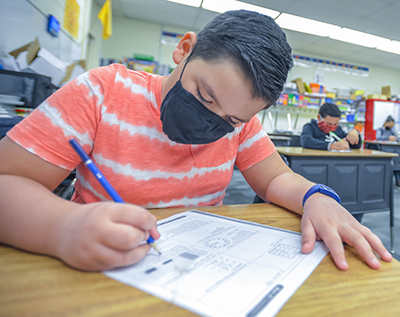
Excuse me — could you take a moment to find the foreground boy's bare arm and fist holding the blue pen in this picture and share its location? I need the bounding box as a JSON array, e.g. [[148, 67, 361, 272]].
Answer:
[[0, 137, 159, 271]]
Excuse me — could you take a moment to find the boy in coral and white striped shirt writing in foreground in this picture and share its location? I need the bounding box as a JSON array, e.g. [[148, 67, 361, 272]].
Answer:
[[0, 11, 392, 271]]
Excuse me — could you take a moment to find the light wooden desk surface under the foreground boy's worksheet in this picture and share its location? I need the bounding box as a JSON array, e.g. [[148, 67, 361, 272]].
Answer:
[[0, 204, 400, 317]]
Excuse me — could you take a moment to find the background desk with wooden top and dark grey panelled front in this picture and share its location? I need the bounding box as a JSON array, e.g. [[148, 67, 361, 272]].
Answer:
[[277, 147, 397, 252]]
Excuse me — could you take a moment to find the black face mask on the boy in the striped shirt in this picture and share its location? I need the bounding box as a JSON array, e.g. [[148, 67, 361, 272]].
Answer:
[[161, 56, 234, 144]]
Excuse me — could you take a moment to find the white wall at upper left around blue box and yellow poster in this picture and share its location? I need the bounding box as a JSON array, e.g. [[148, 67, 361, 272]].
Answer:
[[0, 0, 92, 64]]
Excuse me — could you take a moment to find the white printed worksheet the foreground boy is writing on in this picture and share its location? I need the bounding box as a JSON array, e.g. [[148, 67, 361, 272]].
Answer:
[[104, 210, 328, 317]]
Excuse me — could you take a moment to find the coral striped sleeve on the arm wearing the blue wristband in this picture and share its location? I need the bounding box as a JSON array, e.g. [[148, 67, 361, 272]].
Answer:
[[235, 116, 276, 171]]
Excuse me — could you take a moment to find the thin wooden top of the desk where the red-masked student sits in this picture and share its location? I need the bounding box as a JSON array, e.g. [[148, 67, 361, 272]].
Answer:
[[276, 146, 398, 157]]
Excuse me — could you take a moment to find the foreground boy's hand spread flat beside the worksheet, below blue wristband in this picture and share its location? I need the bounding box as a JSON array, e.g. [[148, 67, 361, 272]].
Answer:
[[301, 194, 392, 271]]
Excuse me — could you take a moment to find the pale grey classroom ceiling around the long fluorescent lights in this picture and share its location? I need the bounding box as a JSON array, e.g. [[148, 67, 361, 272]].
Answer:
[[95, 0, 400, 70]]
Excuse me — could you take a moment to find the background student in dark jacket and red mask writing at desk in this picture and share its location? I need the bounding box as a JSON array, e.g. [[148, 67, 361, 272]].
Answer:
[[300, 103, 361, 151]]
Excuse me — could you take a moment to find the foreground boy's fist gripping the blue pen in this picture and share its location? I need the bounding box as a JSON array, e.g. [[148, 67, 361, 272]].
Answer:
[[56, 202, 160, 271]]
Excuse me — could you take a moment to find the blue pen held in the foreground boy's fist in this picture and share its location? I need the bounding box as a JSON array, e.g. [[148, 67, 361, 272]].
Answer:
[[69, 139, 161, 254]]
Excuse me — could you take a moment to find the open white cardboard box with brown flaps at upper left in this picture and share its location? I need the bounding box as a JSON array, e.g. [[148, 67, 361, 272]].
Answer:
[[9, 37, 85, 86]]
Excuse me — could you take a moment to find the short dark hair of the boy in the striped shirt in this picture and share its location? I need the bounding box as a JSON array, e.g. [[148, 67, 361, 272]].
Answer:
[[191, 10, 293, 105]]
